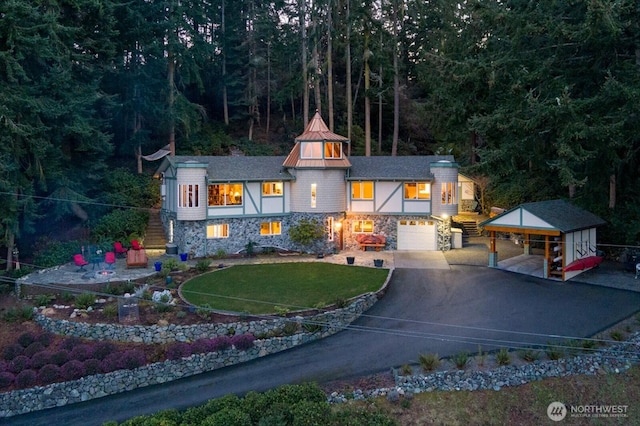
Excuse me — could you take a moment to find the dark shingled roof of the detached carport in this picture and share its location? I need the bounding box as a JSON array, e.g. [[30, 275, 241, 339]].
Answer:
[[480, 200, 607, 233]]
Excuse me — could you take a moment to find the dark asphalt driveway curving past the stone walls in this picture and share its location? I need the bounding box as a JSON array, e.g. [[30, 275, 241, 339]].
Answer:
[[6, 265, 640, 426]]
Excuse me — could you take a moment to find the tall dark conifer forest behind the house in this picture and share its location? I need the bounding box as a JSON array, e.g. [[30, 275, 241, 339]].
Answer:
[[0, 0, 640, 262]]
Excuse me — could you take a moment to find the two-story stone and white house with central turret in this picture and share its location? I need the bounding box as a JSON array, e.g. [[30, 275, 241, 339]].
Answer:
[[157, 113, 461, 257]]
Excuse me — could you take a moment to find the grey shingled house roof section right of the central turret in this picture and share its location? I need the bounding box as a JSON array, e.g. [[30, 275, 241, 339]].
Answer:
[[347, 155, 454, 181]]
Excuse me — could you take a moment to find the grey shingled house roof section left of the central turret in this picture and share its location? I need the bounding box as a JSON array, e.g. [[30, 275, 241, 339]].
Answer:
[[159, 155, 293, 181]]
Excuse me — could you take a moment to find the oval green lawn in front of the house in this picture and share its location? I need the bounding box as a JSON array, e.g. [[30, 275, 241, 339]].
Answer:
[[181, 262, 389, 314]]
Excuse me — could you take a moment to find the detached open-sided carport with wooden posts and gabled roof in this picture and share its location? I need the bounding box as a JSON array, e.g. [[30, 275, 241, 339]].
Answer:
[[480, 200, 606, 281]]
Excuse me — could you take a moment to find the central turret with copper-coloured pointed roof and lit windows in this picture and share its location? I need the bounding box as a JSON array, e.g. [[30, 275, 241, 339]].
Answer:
[[282, 111, 351, 213]]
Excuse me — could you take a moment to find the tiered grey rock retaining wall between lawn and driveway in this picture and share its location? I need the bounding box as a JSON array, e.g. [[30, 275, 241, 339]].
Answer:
[[0, 292, 380, 417]]
